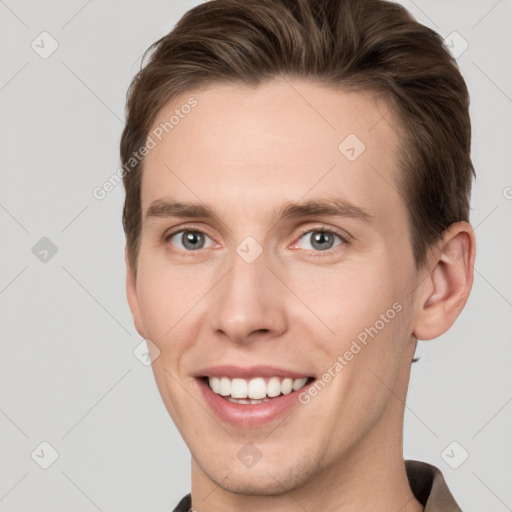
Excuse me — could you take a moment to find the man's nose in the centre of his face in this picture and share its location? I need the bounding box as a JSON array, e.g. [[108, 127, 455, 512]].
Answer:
[[210, 245, 287, 344]]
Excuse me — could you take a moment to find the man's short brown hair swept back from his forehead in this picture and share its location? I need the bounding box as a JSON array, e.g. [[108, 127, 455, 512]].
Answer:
[[121, 0, 475, 272]]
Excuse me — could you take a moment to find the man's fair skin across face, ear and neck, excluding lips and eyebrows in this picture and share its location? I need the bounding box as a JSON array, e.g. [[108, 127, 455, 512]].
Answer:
[[127, 78, 475, 512]]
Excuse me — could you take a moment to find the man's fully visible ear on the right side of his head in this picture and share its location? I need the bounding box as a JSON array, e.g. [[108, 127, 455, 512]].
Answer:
[[413, 222, 476, 340]]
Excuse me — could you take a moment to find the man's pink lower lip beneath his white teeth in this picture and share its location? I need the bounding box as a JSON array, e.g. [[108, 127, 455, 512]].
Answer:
[[197, 379, 314, 427]]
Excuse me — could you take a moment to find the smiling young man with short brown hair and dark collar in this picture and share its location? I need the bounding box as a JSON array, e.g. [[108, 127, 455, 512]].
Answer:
[[121, 0, 475, 512]]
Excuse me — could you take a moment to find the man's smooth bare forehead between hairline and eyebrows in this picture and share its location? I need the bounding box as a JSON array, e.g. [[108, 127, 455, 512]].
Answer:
[[142, 79, 404, 230]]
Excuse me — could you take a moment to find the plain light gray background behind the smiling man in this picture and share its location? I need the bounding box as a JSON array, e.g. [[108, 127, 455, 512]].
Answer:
[[0, 0, 512, 512]]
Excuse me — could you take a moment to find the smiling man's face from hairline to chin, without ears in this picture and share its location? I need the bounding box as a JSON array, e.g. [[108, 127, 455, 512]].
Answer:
[[128, 80, 424, 494]]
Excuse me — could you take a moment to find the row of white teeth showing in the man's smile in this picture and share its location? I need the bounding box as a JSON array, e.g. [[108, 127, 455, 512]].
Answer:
[[208, 377, 308, 398]]
